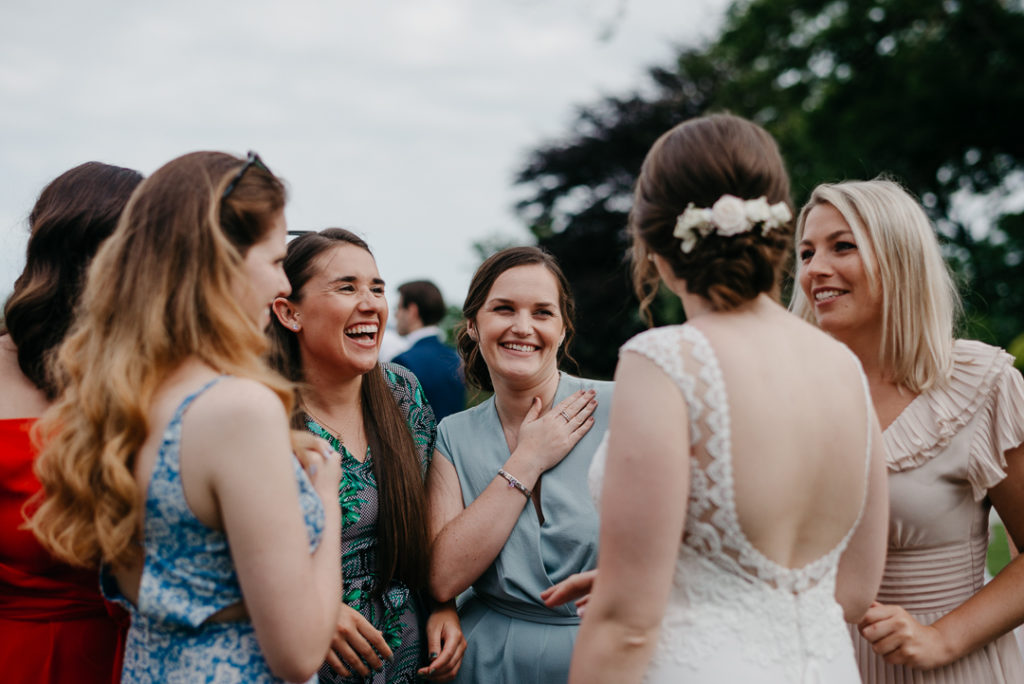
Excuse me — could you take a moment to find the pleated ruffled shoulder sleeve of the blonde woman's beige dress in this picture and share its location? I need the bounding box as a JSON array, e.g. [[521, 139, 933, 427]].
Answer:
[[885, 340, 1024, 500]]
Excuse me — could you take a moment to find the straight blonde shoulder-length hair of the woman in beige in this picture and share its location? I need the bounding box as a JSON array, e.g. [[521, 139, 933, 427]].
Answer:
[[790, 178, 961, 392]]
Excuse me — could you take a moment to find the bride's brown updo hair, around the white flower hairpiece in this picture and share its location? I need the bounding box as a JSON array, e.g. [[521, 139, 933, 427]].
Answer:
[[630, 114, 793, 319]]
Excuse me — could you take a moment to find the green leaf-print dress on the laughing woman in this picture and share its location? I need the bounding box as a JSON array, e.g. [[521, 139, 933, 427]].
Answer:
[[305, 364, 437, 684]]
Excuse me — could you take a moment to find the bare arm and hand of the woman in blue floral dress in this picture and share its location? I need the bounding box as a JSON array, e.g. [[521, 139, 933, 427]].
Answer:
[[197, 379, 341, 681]]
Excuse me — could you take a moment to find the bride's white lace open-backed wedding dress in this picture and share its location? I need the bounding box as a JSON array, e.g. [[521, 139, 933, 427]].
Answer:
[[590, 325, 870, 684]]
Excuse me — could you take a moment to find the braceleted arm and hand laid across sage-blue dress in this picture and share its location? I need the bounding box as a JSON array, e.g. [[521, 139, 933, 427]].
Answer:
[[427, 390, 597, 603]]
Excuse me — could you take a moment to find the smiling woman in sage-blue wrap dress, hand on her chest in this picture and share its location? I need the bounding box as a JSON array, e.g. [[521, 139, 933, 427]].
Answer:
[[427, 247, 611, 684]]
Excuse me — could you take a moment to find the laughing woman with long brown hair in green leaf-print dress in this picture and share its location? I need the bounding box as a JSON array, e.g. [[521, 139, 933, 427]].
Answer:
[[271, 228, 465, 684]]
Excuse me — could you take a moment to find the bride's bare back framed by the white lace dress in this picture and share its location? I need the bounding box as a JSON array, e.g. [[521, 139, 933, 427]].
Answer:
[[690, 306, 872, 568]]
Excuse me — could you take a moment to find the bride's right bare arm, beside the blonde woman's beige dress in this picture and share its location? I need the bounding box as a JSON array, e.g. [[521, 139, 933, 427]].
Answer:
[[836, 411, 889, 625]]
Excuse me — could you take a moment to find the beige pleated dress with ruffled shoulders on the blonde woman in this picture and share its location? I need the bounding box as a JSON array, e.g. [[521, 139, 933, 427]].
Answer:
[[851, 340, 1024, 684]]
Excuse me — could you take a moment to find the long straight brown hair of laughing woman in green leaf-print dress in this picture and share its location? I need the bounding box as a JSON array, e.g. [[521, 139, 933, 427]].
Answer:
[[270, 228, 430, 594]]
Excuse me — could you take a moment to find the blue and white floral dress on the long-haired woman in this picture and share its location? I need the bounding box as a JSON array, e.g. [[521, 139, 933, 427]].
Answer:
[[101, 378, 324, 684]]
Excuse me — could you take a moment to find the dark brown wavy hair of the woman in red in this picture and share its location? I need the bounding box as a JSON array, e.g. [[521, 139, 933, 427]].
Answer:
[[0, 162, 142, 401]]
